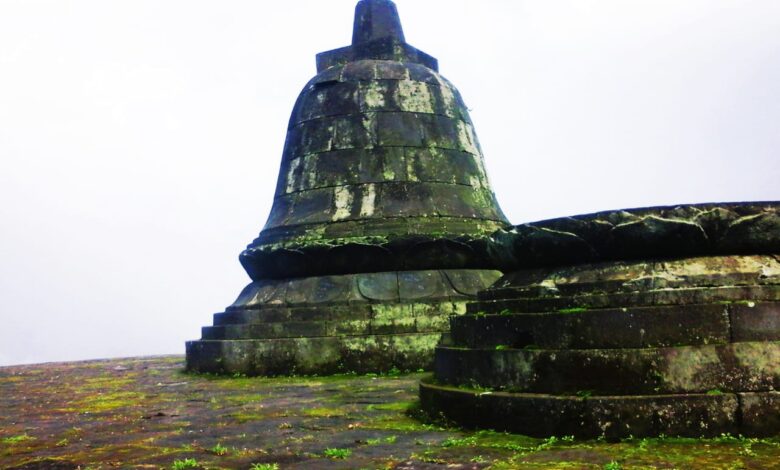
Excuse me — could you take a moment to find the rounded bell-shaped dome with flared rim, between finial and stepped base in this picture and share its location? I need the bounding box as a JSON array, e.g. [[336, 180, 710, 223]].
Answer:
[[241, 59, 508, 278]]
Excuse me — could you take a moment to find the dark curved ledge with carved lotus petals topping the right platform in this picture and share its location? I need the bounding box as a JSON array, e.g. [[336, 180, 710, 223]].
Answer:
[[490, 201, 780, 271]]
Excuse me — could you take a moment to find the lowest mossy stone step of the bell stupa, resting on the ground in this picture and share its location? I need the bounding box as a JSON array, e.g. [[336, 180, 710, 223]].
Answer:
[[187, 333, 441, 376]]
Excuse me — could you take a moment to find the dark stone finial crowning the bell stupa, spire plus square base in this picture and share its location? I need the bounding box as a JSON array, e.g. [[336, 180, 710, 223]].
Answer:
[[317, 0, 439, 72]]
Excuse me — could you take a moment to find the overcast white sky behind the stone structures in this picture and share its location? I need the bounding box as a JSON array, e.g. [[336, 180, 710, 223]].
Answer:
[[0, 0, 780, 365]]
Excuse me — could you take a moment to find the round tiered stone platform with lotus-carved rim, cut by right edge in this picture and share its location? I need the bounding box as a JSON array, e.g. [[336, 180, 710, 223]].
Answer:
[[420, 203, 780, 438]]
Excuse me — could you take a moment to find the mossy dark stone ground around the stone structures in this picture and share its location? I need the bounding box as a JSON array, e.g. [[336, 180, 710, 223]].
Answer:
[[0, 357, 780, 469]]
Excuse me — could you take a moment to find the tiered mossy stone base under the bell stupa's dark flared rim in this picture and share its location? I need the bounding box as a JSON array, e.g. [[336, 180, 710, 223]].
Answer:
[[187, 269, 501, 375]]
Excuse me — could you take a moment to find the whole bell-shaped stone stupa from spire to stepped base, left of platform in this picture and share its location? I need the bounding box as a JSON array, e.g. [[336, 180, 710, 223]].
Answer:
[[187, 0, 508, 374]]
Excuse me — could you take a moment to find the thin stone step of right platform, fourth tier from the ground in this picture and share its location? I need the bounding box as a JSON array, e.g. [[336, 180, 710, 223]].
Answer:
[[468, 285, 780, 313]]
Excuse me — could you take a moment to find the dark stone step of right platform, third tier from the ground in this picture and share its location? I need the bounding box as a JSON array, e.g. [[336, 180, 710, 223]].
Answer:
[[451, 301, 780, 349]]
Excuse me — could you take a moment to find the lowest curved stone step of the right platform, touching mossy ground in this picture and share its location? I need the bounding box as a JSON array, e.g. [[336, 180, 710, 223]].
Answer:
[[420, 380, 780, 440]]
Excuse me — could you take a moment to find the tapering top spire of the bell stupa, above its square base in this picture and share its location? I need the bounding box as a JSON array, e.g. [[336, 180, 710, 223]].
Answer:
[[352, 0, 406, 46]]
